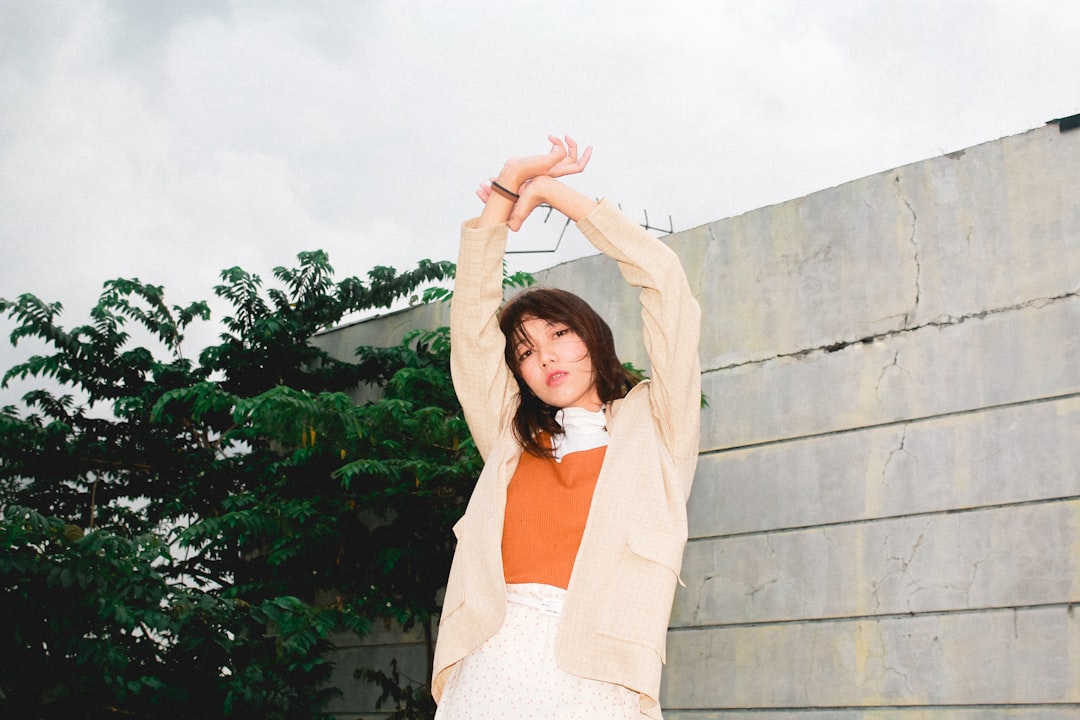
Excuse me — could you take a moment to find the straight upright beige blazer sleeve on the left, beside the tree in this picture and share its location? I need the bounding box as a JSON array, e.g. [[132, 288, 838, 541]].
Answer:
[[450, 219, 518, 461]]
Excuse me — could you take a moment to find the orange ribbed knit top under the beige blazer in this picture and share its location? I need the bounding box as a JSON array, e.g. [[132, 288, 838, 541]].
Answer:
[[502, 446, 607, 589]]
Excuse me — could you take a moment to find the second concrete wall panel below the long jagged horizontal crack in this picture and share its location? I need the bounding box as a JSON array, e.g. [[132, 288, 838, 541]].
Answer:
[[688, 396, 1080, 538]]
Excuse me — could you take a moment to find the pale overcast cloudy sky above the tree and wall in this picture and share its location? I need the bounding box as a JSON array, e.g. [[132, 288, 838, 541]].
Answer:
[[0, 0, 1080, 402]]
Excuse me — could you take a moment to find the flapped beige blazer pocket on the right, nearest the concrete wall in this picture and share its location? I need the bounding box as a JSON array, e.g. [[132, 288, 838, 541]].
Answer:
[[597, 531, 683, 660]]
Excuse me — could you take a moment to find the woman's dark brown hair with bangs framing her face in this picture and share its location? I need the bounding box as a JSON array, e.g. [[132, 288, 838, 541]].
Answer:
[[499, 287, 638, 458]]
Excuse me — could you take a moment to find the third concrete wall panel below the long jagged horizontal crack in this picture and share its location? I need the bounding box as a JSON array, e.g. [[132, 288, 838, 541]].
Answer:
[[672, 500, 1080, 627]]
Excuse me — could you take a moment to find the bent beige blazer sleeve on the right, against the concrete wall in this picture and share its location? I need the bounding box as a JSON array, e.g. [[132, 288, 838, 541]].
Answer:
[[578, 200, 701, 472]]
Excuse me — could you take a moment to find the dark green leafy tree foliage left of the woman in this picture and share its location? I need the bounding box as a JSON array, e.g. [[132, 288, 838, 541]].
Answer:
[[0, 252, 496, 718]]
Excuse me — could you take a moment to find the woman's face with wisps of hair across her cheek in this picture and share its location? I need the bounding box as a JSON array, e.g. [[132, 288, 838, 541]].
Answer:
[[514, 317, 603, 410]]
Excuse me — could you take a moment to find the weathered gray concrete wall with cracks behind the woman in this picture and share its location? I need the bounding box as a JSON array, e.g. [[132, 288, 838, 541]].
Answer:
[[320, 124, 1080, 720]]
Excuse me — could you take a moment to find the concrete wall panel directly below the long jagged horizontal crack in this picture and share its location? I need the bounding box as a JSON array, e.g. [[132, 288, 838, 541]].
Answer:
[[701, 296, 1080, 451]]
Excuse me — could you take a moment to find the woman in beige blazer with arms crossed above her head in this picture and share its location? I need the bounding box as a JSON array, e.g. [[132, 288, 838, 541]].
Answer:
[[432, 137, 701, 720]]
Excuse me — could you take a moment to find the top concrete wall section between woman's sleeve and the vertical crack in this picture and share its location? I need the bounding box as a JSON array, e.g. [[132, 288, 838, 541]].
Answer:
[[673, 176, 917, 368]]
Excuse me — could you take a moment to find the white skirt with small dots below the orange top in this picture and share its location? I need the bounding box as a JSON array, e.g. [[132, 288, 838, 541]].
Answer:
[[435, 583, 644, 720]]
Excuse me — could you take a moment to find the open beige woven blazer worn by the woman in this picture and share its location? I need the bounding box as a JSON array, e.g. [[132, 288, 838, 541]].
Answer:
[[432, 201, 701, 719]]
